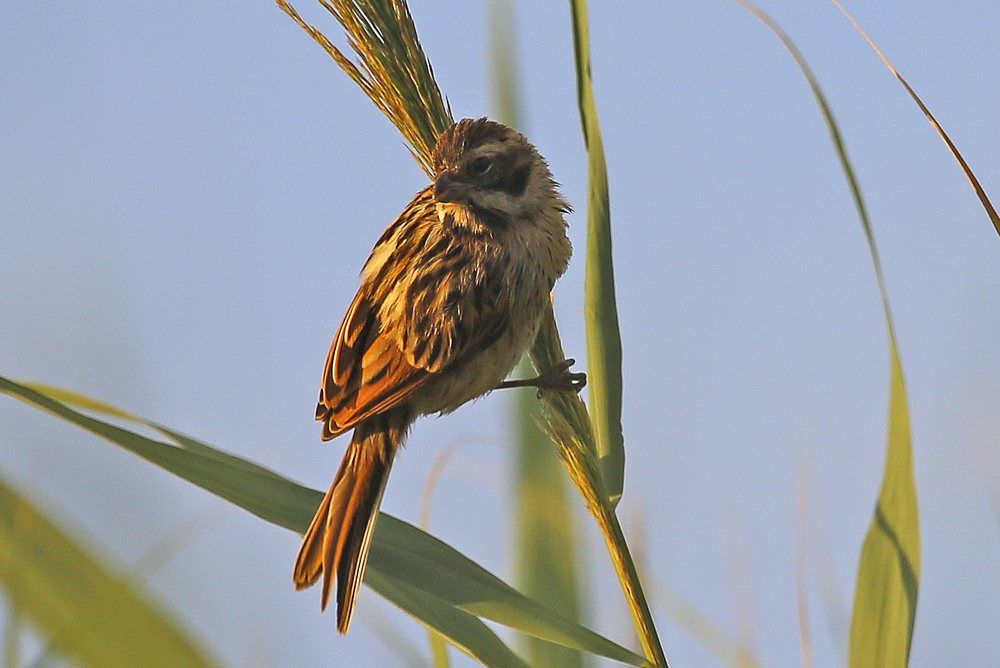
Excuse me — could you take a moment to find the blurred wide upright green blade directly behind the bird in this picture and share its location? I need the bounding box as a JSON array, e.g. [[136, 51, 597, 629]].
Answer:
[[489, 0, 583, 668]]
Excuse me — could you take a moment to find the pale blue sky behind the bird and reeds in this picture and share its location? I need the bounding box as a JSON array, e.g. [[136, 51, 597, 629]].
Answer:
[[0, 0, 1000, 667]]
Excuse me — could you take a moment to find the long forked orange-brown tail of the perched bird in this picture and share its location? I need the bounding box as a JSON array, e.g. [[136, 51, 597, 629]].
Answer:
[[293, 410, 410, 633]]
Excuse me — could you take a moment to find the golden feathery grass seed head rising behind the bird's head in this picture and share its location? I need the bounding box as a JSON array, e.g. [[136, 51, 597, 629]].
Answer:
[[275, 0, 453, 176]]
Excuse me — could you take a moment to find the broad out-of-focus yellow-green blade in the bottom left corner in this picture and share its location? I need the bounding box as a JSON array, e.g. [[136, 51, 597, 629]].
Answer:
[[0, 479, 221, 668]]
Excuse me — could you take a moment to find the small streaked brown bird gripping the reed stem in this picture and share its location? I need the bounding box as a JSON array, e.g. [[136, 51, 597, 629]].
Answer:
[[294, 118, 585, 633]]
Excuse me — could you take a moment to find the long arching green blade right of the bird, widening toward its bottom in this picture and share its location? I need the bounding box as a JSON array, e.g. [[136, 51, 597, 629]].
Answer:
[[734, 0, 920, 668]]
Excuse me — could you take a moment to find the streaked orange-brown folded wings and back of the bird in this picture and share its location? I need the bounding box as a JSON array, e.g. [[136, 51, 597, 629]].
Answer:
[[316, 222, 510, 439]]
